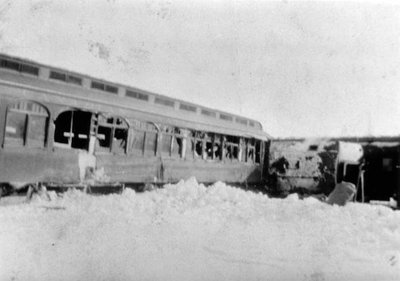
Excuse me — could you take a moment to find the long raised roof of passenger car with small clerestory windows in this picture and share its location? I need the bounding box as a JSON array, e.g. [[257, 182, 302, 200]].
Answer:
[[0, 54, 270, 139]]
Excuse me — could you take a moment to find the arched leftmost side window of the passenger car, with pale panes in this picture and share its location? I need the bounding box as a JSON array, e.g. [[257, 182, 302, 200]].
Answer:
[[4, 101, 49, 147]]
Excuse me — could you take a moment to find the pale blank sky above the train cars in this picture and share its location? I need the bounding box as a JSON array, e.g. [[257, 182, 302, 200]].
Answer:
[[0, 0, 400, 137]]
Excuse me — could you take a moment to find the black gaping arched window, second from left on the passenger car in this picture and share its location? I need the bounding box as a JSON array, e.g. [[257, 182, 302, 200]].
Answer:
[[54, 110, 92, 150]]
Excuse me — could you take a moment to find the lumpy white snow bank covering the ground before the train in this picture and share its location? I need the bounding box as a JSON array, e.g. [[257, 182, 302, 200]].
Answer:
[[0, 178, 400, 281]]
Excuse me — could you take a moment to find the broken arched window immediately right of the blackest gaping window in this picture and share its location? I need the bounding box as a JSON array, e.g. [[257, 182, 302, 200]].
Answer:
[[96, 115, 129, 154]]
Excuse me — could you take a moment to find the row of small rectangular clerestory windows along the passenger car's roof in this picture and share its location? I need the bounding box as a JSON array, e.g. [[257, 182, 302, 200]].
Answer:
[[0, 59, 255, 127]]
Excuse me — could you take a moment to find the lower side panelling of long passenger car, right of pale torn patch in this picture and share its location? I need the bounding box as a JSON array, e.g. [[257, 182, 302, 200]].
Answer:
[[97, 154, 261, 183]]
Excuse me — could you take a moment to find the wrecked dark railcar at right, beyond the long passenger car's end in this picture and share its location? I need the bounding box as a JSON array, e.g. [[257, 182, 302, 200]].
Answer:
[[269, 137, 400, 207]]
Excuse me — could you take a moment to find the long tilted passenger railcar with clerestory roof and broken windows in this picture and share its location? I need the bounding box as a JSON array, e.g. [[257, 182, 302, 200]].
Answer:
[[0, 52, 269, 194]]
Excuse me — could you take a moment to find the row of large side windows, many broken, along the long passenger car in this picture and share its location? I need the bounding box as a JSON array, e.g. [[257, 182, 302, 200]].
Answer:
[[4, 101, 261, 163]]
